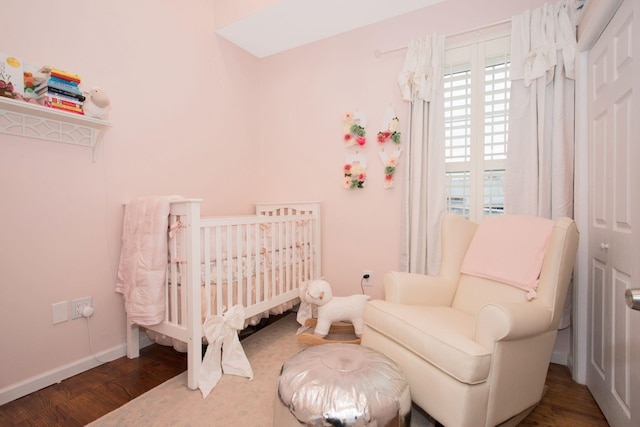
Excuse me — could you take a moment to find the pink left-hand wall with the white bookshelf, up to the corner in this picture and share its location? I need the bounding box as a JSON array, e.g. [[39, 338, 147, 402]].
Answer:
[[0, 0, 258, 390]]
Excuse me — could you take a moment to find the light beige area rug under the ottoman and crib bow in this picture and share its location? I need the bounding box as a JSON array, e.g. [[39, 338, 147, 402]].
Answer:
[[89, 313, 433, 427]]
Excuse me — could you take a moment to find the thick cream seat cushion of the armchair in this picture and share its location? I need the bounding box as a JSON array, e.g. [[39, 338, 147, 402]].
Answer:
[[364, 300, 491, 384]]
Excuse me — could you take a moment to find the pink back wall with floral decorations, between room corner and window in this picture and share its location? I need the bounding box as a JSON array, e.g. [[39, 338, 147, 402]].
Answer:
[[252, 0, 543, 297]]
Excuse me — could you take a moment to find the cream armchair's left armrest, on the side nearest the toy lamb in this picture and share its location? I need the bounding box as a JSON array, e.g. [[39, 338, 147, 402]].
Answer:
[[383, 271, 456, 306]]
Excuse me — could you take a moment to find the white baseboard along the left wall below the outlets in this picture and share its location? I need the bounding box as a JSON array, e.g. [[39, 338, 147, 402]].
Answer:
[[0, 334, 153, 405]]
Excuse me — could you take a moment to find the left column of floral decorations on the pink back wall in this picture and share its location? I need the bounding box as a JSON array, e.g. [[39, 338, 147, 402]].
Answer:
[[342, 111, 367, 190]]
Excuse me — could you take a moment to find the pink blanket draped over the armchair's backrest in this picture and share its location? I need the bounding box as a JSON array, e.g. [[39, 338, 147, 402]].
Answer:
[[460, 215, 554, 298]]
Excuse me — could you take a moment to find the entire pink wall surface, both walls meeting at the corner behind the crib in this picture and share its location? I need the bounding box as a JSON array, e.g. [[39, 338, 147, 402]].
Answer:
[[0, 0, 543, 398]]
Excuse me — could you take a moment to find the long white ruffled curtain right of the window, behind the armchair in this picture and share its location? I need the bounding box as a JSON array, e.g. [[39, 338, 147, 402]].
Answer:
[[505, 1, 577, 329]]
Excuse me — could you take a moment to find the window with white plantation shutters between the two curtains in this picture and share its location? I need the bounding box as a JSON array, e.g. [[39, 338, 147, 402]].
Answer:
[[444, 36, 510, 221]]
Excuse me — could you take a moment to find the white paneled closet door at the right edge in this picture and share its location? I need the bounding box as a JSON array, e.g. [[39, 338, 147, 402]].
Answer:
[[587, 0, 640, 427]]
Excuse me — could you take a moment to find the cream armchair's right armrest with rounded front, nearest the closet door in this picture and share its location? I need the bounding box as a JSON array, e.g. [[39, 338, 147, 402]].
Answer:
[[474, 302, 553, 348]]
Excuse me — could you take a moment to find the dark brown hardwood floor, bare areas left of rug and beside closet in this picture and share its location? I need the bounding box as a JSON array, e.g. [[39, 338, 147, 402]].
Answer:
[[0, 344, 608, 427]]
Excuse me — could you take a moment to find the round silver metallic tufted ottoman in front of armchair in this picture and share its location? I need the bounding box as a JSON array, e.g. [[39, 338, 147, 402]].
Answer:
[[273, 344, 411, 427]]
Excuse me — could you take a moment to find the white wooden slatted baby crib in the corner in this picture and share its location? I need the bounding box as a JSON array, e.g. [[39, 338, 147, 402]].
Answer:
[[127, 199, 321, 389]]
